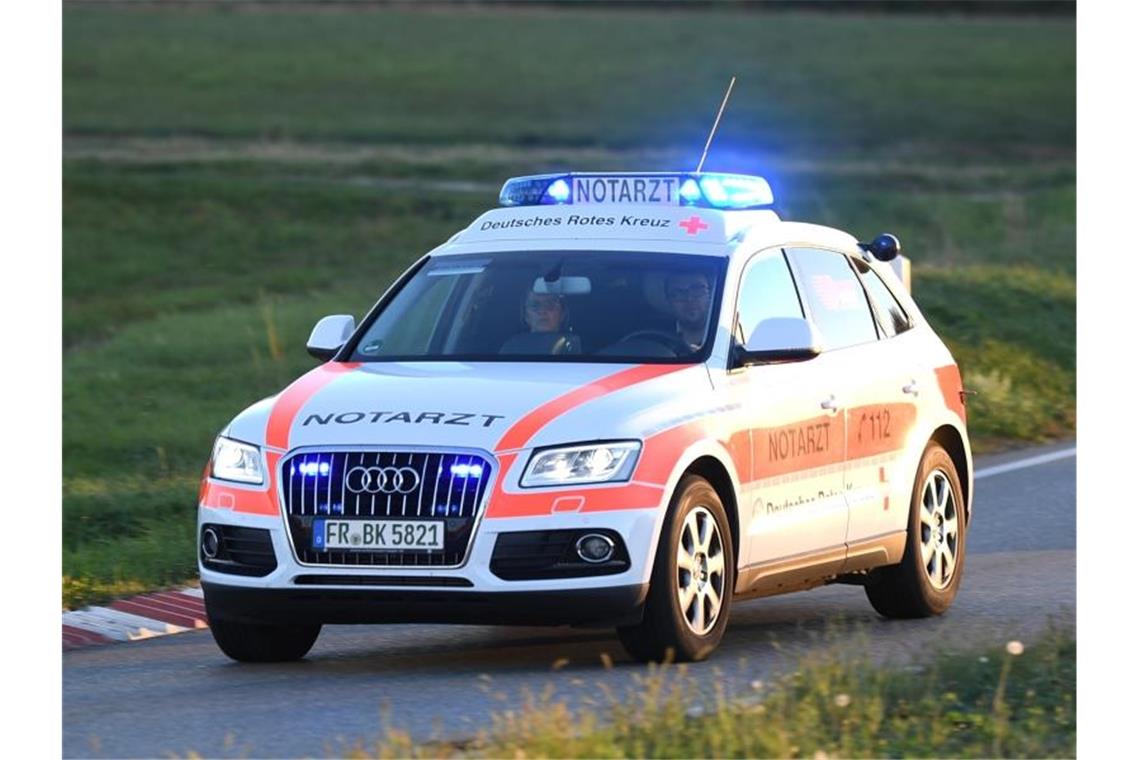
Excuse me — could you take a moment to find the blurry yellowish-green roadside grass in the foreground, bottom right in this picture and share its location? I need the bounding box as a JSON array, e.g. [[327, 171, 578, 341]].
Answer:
[[345, 630, 1076, 758]]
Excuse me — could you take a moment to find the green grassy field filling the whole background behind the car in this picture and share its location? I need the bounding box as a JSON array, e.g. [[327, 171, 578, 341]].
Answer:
[[63, 6, 1076, 604]]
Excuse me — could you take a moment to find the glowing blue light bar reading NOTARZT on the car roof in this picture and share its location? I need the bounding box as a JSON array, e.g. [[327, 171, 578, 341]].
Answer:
[[499, 172, 775, 210]]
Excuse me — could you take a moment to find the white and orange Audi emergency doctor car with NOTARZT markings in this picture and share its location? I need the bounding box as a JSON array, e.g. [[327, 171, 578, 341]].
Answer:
[[198, 173, 972, 661]]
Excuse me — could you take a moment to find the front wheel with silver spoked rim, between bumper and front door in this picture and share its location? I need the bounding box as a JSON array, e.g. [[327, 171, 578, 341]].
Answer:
[[618, 475, 736, 662]]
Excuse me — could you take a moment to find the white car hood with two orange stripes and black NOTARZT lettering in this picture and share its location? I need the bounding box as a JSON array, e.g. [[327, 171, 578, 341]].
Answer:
[[226, 362, 710, 451]]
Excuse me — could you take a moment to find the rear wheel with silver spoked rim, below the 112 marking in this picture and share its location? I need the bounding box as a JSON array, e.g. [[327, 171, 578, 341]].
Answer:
[[864, 441, 967, 619]]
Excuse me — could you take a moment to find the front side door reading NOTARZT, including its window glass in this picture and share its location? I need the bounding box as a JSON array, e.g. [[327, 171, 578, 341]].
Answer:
[[727, 248, 847, 569]]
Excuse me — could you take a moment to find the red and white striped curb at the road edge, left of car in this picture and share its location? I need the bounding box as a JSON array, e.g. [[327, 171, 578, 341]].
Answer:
[[63, 587, 207, 649]]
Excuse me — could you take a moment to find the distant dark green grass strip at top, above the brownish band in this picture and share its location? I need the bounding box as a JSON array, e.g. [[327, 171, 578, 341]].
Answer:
[[64, 8, 1076, 158]]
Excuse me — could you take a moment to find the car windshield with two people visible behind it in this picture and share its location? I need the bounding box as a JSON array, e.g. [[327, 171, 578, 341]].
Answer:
[[350, 251, 725, 363]]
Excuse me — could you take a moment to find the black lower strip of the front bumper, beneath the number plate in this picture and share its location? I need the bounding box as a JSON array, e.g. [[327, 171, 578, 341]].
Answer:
[[202, 581, 649, 627]]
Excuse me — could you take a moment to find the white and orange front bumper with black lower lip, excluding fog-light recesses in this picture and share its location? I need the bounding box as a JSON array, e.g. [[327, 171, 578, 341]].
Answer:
[[198, 505, 660, 626]]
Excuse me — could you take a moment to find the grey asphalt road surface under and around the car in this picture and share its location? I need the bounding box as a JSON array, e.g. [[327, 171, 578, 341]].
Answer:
[[63, 442, 1076, 757]]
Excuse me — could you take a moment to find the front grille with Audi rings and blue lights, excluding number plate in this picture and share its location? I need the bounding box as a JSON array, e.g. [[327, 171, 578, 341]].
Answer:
[[280, 451, 494, 567]]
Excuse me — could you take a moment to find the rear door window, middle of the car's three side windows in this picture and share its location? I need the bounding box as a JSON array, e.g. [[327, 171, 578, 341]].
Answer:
[[788, 248, 879, 350]]
